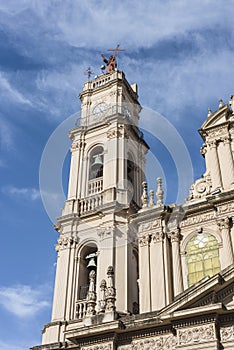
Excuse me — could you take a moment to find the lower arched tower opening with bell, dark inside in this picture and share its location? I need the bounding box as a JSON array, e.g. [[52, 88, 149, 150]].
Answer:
[[78, 243, 97, 300]]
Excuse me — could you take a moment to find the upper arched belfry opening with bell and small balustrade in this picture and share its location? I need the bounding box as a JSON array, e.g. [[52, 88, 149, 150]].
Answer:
[[88, 146, 104, 195]]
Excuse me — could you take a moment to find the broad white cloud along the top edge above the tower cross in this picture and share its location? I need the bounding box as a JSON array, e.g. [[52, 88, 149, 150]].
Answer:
[[17, 0, 233, 48]]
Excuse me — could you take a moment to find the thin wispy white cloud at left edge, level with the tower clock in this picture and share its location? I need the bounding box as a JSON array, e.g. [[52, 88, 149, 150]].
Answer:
[[0, 72, 32, 106]]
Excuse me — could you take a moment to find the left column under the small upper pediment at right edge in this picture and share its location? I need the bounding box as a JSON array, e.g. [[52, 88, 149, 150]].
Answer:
[[207, 141, 222, 190]]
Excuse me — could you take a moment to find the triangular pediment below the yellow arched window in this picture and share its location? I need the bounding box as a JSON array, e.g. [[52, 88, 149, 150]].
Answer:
[[158, 265, 234, 319]]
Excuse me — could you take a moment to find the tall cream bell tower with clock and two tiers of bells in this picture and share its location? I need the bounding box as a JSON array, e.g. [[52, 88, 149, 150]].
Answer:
[[43, 69, 149, 344]]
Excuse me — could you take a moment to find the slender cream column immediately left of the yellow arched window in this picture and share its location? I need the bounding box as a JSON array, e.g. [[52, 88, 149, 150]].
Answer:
[[168, 228, 183, 297]]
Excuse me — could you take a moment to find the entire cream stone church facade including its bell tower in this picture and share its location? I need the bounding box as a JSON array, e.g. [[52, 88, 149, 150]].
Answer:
[[32, 69, 234, 350]]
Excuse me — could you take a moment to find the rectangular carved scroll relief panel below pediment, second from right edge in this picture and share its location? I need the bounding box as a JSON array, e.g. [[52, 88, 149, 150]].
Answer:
[[178, 324, 215, 345]]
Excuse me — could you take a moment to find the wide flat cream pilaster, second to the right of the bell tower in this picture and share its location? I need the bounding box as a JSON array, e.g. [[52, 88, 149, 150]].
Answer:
[[150, 231, 166, 311]]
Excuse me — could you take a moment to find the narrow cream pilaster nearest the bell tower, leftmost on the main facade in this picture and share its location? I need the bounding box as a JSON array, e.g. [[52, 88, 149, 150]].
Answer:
[[139, 234, 151, 313]]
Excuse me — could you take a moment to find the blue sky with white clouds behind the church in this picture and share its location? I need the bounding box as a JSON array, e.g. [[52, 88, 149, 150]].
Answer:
[[0, 0, 234, 350]]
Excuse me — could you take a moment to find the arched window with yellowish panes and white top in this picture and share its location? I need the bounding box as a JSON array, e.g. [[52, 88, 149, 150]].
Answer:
[[186, 233, 220, 287]]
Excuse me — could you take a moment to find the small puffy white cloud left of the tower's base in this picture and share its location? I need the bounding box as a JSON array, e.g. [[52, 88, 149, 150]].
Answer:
[[0, 285, 50, 318]]
